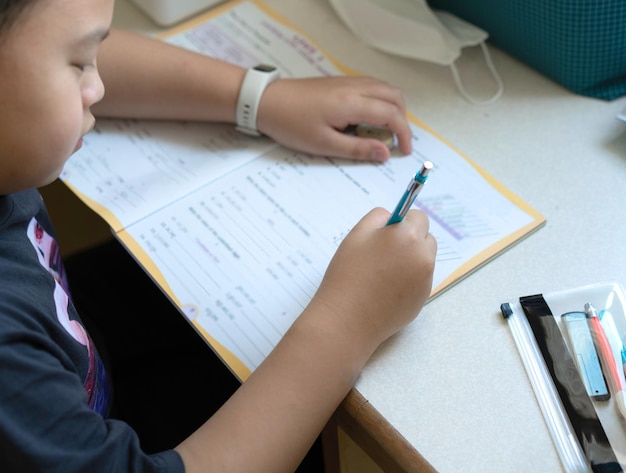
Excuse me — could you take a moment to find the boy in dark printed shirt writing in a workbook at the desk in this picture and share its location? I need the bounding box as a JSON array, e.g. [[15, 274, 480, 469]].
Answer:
[[0, 0, 436, 473]]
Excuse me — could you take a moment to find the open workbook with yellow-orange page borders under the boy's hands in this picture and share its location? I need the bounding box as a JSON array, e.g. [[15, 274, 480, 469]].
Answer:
[[61, 1, 545, 380]]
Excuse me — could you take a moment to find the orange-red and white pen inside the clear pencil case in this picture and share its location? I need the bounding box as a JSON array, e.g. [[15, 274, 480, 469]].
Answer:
[[585, 302, 626, 419]]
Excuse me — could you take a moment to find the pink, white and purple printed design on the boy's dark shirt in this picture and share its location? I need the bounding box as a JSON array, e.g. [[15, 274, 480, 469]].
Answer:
[[27, 218, 111, 416]]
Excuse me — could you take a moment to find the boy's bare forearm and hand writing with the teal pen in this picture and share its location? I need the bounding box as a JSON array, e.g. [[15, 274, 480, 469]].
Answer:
[[172, 209, 436, 473]]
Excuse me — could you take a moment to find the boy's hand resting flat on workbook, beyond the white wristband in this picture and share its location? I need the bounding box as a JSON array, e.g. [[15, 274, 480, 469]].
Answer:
[[257, 77, 411, 162]]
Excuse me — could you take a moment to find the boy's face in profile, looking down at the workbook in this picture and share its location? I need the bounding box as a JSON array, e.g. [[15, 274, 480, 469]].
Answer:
[[0, 0, 114, 195]]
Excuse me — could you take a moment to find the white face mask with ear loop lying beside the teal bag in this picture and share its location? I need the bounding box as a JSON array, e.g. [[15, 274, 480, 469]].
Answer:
[[329, 0, 503, 104]]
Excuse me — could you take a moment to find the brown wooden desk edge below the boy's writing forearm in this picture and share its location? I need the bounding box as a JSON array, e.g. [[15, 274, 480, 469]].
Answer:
[[333, 388, 437, 473]]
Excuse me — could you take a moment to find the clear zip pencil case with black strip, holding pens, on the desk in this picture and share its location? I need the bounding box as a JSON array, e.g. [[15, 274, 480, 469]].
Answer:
[[500, 282, 626, 473]]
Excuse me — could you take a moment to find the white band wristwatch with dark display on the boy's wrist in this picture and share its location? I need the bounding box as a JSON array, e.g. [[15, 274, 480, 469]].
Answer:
[[236, 64, 280, 136]]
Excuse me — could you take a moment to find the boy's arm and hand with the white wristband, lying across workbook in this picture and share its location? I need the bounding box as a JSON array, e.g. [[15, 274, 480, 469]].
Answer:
[[92, 30, 411, 161]]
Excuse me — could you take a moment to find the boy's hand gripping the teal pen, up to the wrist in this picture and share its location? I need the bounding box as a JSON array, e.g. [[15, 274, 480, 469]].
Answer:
[[312, 209, 437, 350]]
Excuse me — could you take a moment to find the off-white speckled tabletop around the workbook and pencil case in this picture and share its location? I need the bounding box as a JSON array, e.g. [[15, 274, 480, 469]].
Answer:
[[114, 0, 626, 473]]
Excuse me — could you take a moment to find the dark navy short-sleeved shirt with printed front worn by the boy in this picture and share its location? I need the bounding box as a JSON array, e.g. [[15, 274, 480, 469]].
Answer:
[[0, 189, 184, 473]]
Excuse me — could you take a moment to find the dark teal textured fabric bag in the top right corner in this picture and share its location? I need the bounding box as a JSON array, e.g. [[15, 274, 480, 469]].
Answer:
[[428, 0, 626, 100]]
